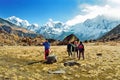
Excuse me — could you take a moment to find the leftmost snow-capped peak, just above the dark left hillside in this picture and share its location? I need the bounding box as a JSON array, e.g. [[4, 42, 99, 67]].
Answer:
[[6, 16, 38, 31]]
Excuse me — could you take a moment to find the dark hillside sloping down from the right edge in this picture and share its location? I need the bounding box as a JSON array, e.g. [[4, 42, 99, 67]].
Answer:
[[100, 24, 120, 41]]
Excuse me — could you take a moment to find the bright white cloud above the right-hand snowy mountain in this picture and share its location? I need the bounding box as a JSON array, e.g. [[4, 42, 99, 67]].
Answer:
[[66, 0, 120, 26]]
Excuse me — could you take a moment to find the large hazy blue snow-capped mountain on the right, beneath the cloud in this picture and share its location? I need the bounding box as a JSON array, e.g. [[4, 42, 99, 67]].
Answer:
[[68, 16, 120, 40]]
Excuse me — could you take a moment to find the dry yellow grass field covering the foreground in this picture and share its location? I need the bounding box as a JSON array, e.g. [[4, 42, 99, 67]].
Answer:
[[0, 42, 120, 80]]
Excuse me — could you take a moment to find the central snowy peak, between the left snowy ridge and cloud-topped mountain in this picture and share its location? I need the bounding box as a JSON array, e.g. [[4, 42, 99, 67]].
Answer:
[[36, 19, 69, 39]]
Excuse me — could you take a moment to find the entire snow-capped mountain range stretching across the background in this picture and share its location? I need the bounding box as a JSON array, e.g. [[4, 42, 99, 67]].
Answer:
[[7, 15, 120, 41]]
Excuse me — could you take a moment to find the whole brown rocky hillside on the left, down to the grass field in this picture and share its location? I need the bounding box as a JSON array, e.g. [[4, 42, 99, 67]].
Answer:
[[0, 18, 45, 46]]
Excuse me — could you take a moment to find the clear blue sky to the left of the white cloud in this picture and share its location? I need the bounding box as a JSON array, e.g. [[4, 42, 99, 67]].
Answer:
[[0, 0, 78, 23]]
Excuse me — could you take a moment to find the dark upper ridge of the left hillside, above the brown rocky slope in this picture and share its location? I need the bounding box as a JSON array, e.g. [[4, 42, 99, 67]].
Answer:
[[0, 18, 37, 37]]
